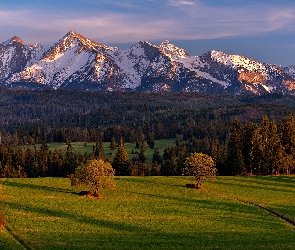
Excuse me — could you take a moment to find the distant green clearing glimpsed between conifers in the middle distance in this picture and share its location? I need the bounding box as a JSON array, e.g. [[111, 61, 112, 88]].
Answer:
[[30, 139, 175, 162]]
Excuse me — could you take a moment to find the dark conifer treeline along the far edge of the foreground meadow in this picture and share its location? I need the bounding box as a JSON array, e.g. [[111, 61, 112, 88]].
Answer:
[[0, 115, 295, 177]]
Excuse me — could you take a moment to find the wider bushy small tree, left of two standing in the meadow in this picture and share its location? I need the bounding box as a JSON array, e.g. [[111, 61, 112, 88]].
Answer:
[[71, 159, 116, 197]]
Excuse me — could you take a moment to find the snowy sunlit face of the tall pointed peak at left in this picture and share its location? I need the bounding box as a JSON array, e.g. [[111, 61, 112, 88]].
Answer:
[[8, 31, 116, 88]]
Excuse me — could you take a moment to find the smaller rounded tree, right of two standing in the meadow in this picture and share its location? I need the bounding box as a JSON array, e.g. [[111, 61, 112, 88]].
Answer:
[[185, 153, 217, 189]]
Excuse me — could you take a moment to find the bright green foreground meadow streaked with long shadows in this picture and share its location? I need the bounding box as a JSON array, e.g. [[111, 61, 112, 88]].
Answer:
[[0, 176, 295, 250]]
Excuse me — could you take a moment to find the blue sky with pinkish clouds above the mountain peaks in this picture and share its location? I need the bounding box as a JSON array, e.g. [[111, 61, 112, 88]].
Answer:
[[0, 0, 295, 66]]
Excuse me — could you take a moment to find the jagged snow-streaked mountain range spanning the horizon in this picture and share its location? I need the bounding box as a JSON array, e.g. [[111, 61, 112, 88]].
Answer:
[[0, 31, 295, 95]]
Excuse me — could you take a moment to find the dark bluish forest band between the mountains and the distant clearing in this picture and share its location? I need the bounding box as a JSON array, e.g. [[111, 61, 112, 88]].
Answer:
[[0, 88, 295, 146]]
